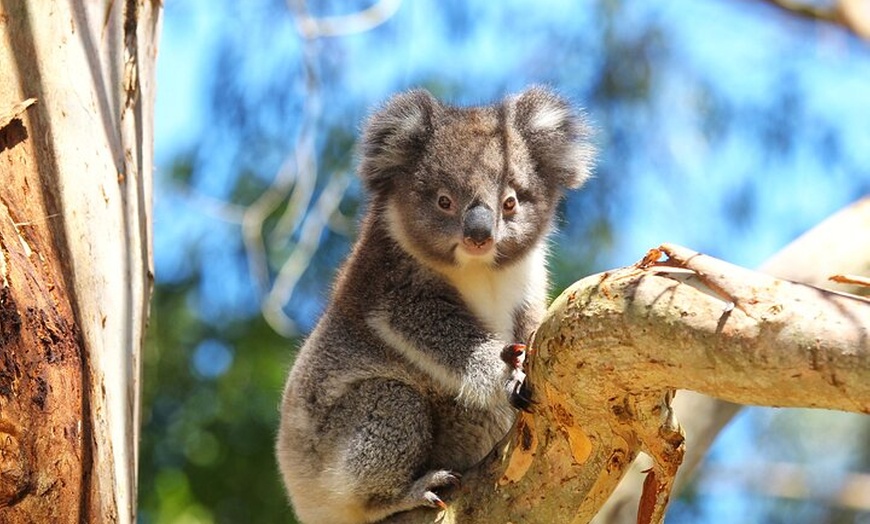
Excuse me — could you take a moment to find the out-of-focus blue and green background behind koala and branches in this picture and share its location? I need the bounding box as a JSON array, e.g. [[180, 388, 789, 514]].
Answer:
[[139, 0, 870, 524]]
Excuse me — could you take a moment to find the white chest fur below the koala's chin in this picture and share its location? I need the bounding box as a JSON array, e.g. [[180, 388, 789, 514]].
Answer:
[[447, 247, 547, 342]]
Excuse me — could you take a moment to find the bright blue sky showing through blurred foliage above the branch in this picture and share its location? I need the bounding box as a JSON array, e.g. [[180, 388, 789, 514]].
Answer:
[[156, 0, 870, 277]]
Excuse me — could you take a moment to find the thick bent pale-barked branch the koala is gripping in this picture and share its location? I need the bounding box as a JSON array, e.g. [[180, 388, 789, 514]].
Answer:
[[404, 246, 870, 523]]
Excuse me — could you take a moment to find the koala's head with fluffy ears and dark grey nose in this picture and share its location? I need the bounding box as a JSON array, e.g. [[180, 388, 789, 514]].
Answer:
[[360, 87, 593, 268]]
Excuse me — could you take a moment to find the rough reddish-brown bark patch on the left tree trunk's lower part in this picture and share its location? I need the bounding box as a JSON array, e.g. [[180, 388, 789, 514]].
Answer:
[[0, 192, 83, 523]]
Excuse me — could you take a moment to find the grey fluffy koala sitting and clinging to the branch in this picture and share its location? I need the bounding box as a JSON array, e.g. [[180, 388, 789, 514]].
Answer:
[[276, 87, 593, 524]]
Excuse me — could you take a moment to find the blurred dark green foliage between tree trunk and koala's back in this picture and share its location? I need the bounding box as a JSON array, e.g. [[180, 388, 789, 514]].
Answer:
[[139, 279, 295, 524]]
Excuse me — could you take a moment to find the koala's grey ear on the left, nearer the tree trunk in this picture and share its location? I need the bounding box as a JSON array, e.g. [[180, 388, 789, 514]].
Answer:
[[360, 89, 440, 193]]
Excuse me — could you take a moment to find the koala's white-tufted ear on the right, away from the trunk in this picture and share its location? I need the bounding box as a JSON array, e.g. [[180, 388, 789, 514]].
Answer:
[[509, 86, 595, 188]]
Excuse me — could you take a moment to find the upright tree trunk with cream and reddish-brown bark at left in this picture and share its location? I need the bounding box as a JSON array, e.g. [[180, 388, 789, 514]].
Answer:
[[0, 0, 160, 523]]
